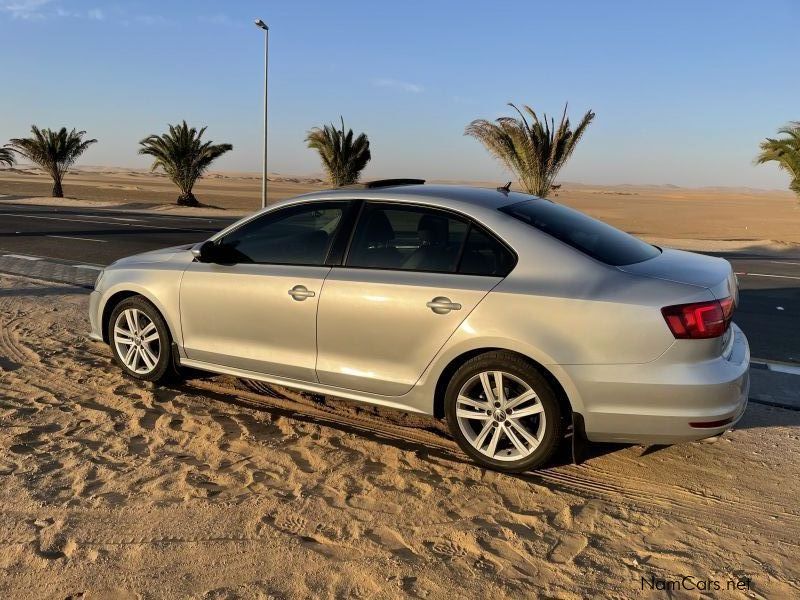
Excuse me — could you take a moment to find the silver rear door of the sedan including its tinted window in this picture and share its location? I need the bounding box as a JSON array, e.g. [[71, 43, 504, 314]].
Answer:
[[317, 202, 513, 396]]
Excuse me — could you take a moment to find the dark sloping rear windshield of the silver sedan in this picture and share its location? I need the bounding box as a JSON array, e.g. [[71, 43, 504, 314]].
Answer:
[[500, 199, 661, 266]]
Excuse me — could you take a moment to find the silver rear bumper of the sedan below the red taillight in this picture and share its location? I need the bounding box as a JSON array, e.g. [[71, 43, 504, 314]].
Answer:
[[565, 324, 750, 444]]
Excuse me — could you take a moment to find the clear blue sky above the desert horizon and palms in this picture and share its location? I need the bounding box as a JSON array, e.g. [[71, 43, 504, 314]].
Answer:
[[0, 0, 800, 189]]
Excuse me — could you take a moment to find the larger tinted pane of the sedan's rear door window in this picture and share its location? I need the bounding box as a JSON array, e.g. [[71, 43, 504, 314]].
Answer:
[[346, 203, 468, 273]]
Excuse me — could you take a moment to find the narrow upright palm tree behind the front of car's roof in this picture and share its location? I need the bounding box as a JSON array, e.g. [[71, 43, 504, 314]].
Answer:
[[306, 117, 372, 186]]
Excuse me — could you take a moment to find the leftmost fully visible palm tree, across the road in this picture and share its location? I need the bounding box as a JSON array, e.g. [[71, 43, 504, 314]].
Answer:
[[8, 125, 97, 198]]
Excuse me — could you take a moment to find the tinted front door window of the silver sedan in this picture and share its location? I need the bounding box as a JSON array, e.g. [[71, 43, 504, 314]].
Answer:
[[220, 202, 347, 265]]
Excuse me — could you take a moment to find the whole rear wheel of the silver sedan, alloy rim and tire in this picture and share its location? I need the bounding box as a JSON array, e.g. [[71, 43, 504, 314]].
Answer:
[[445, 351, 564, 472]]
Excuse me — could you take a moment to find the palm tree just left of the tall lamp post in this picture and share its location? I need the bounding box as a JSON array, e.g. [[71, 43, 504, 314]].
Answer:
[[139, 121, 233, 206]]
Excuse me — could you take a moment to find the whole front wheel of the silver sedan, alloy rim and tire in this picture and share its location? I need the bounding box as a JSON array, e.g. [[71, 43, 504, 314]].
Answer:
[[108, 296, 172, 381]]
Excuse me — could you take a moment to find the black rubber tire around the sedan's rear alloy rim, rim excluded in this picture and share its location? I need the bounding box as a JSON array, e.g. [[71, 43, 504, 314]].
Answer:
[[444, 350, 566, 473]]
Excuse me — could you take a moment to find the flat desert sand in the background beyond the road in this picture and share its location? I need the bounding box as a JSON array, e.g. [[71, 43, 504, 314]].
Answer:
[[0, 167, 800, 252]]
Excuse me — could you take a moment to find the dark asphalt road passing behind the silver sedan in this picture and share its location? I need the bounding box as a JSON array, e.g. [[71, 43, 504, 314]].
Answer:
[[0, 203, 800, 363]]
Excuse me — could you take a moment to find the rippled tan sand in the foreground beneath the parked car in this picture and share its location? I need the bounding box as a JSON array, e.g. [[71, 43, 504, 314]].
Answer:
[[0, 277, 800, 599]]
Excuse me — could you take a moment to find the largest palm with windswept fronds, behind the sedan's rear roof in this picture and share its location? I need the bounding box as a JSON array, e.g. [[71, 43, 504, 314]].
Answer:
[[464, 103, 594, 198]]
